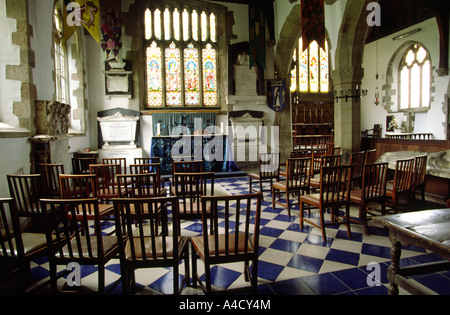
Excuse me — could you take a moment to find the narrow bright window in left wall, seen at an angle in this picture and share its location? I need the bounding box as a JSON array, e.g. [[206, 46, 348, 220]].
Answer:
[[53, 2, 69, 104]]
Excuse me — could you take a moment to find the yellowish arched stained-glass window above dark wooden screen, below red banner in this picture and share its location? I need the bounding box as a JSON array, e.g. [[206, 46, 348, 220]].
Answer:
[[291, 37, 330, 93]]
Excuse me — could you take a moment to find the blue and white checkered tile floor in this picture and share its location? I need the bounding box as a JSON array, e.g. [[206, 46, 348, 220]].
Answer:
[[22, 178, 450, 295]]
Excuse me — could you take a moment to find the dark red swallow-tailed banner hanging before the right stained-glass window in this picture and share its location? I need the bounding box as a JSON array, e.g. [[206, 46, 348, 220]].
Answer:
[[301, 0, 326, 51]]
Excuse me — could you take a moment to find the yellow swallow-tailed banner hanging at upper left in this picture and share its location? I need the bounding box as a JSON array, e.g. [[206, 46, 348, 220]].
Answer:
[[63, 0, 100, 44]]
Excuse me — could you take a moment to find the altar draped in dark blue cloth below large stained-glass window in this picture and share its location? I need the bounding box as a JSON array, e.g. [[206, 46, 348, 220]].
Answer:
[[150, 134, 239, 175]]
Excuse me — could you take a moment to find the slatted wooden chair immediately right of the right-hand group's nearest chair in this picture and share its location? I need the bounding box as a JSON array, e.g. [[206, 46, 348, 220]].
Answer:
[[350, 163, 388, 235]]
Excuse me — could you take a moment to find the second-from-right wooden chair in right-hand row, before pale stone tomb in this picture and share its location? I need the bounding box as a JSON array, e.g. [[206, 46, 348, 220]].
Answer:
[[386, 158, 414, 213]]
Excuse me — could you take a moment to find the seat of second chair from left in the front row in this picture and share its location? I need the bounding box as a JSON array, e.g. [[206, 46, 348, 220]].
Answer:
[[55, 235, 118, 258]]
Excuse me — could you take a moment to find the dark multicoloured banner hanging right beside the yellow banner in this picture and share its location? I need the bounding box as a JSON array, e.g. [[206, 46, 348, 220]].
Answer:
[[100, 0, 122, 61]]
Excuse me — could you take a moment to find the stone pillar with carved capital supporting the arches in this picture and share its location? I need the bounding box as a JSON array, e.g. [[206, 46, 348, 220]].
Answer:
[[331, 68, 364, 153]]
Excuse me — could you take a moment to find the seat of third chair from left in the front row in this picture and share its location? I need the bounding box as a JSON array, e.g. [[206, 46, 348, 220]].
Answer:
[[125, 236, 187, 260]]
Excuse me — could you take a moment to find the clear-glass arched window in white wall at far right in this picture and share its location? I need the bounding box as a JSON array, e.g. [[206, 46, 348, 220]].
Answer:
[[398, 44, 431, 110]]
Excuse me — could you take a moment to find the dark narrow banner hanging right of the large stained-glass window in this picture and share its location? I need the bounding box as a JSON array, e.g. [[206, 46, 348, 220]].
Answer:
[[248, 4, 266, 69]]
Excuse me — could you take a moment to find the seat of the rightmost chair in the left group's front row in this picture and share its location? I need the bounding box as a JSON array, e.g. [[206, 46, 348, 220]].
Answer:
[[191, 233, 254, 260]]
